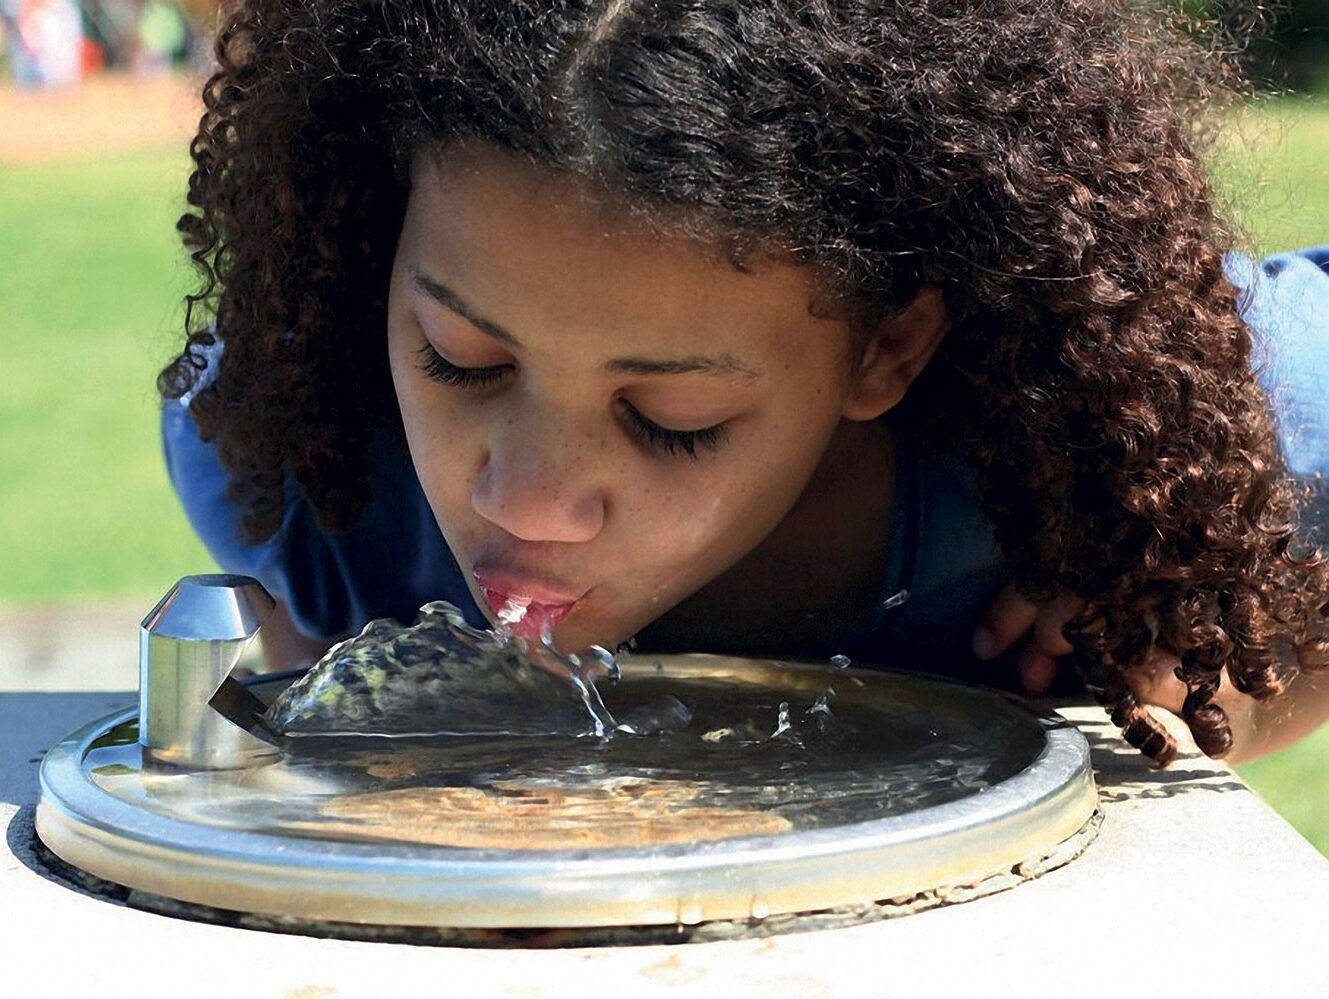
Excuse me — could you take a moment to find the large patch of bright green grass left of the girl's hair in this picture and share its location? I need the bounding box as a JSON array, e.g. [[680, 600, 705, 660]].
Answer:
[[0, 146, 211, 606]]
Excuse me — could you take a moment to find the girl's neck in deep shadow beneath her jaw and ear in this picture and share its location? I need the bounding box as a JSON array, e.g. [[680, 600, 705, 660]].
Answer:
[[638, 421, 894, 656]]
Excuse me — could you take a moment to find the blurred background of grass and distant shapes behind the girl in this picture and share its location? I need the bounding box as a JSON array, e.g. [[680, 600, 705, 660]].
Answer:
[[0, 0, 1329, 854]]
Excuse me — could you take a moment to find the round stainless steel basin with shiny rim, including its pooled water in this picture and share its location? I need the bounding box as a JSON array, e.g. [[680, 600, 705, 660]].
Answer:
[[36, 655, 1096, 927]]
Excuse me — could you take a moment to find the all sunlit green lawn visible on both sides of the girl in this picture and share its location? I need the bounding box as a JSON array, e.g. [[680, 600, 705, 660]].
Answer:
[[0, 104, 1329, 853]]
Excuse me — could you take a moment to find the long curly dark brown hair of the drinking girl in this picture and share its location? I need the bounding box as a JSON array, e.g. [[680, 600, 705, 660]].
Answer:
[[159, 0, 1329, 763]]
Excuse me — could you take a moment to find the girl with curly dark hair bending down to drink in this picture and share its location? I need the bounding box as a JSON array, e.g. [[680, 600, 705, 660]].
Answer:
[[159, 0, 1329, 763]]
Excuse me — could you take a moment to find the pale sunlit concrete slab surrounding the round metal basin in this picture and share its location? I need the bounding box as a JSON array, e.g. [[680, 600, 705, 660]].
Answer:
[[0, 685, 1329, 999]]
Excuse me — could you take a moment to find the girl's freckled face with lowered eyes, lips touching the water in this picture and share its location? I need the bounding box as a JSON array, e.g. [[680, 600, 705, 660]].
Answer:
[[388, 146, 880, 650]]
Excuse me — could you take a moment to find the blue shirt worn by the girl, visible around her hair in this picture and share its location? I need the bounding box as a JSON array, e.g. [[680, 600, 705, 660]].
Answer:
[[162, 247, 1329, 681]]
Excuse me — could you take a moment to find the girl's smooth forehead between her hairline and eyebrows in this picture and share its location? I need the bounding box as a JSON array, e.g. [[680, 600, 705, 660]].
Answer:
[[401, 145, 847, 366]]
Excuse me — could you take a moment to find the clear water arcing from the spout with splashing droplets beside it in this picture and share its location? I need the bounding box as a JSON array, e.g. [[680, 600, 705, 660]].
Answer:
[[264, 599, 852, 745]]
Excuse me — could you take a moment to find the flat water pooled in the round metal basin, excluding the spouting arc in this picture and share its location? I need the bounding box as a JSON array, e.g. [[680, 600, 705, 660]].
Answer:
[[86, 648, 1042, 850]]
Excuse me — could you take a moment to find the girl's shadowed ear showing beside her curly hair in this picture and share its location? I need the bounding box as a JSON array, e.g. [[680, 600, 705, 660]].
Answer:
[[841, 284, 950, 420]]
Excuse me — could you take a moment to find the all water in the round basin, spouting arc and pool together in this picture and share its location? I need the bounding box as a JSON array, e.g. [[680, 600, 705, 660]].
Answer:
[[67, 602, 1042, 850]]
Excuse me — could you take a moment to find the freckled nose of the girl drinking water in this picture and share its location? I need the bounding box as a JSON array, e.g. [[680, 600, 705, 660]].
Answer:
[[470, 413, 606, 542]]
